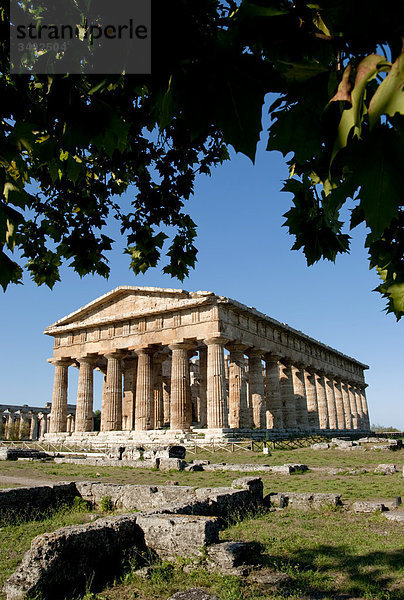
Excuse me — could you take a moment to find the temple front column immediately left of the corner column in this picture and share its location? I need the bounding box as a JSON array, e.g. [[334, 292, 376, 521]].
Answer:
[[168, 342, 192, 431]]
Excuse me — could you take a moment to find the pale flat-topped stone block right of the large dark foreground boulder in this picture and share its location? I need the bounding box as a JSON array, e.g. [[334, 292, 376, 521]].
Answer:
[[137, 513, 219, 558]]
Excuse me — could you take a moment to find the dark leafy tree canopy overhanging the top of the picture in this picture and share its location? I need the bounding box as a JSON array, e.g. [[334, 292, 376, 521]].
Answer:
[[0, 0, 404, 318]]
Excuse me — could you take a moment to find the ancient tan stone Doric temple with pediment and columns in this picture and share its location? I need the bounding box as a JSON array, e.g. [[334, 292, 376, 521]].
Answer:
[[44, 286, 369, 440]]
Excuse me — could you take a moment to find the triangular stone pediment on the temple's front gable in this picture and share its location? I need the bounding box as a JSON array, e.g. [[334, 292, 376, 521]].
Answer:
[[44, 286, 214, 335]]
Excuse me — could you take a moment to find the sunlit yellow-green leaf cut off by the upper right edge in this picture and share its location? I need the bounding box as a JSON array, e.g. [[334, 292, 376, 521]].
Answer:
[[369, 53, 404, 129]]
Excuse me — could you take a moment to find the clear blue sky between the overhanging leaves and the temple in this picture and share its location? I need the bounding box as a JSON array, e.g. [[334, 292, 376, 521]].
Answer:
[[0, 124, 404, 430]]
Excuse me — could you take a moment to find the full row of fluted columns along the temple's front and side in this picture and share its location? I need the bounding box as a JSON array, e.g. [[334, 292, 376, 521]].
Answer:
[[50, 336, 369, 433]]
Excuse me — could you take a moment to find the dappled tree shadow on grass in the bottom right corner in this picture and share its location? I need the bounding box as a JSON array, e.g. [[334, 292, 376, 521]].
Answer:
[[248, 542, 404, 600]]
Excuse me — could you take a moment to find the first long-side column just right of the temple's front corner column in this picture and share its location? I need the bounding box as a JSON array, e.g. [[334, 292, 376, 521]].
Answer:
[[229, 344, 251, 429]]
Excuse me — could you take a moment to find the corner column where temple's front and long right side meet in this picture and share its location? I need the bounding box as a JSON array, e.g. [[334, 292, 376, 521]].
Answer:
[[205, 337, 228, 429]]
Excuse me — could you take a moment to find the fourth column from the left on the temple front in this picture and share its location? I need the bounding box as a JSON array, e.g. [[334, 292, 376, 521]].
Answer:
[[135, 348, 154, 431]]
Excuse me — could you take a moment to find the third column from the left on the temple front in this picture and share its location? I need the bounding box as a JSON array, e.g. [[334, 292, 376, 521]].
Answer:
[[101, 352, 123, 431]]
